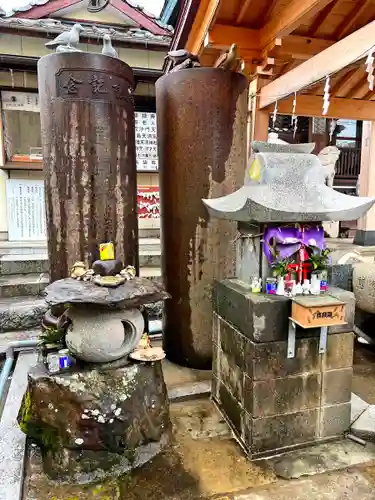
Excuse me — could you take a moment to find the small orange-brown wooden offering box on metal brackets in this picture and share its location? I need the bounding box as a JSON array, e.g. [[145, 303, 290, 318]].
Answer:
[[291, 295, 346, 328]]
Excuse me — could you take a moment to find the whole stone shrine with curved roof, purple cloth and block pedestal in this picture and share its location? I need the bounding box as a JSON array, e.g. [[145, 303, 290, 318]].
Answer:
[[203, 143, 375, 459]]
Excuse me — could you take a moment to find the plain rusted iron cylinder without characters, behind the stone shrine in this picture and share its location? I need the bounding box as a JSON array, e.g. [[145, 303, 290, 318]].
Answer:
[[156, 68, 248, 368]]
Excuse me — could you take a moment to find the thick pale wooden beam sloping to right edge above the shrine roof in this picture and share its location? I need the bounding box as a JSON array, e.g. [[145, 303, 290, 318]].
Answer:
[[260, 21, 375, 108]]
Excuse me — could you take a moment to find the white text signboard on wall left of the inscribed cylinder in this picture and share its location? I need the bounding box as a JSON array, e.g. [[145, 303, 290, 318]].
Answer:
[[7, 179, 47, 241]]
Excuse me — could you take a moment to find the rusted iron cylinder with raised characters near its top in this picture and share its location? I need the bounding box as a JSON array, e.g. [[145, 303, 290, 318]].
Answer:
[[38, 53, 138, 281]]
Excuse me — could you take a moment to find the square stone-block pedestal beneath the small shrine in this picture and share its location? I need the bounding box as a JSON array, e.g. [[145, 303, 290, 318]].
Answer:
[[212, 280, 355, 459]]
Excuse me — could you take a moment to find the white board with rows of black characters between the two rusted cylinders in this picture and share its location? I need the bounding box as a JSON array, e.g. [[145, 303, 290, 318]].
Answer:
[[135, 111, 158, 171]]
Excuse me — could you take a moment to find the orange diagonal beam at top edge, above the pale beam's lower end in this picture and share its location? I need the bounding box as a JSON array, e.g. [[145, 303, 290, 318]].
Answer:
[[260, 0, 333, 47]]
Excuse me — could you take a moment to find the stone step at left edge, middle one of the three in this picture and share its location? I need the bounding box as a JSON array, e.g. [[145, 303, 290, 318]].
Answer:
[[0, 273, 49, 299]]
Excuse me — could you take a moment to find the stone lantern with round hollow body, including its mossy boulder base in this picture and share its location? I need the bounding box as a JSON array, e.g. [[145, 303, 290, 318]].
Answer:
[[18, 252, 170, 483]]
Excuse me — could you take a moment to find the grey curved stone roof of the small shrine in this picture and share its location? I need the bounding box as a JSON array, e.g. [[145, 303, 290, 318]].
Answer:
[[203, 149, 375, 223]]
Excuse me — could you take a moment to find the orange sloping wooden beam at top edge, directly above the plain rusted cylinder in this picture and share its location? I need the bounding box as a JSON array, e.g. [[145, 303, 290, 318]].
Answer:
[[185, 0, 221, 54]]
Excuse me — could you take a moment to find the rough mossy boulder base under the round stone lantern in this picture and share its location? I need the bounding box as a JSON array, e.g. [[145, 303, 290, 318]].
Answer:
[[18, 361, 170, 483]]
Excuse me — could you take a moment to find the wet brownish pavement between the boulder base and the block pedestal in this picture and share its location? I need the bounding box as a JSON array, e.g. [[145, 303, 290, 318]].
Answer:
[[24, 399, 277, 500]]
